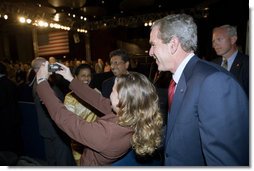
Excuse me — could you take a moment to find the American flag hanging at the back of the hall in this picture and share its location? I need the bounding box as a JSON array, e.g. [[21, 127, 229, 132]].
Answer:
[[38, 31, 69, 56]]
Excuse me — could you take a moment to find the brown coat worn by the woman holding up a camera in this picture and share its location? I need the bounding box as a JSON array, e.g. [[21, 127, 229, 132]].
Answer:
[[37, 79, 133, 166]]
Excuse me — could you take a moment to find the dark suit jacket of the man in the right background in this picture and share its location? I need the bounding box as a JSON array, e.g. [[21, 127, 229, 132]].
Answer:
[[213, 51, 249, 97]]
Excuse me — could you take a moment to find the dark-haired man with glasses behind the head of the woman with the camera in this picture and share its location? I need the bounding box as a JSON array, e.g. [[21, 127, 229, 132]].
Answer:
[[101, 49, 130, 98]]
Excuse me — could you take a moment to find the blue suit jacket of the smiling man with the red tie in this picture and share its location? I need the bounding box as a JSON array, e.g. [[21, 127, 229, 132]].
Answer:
[[165, 56, 249, 166]]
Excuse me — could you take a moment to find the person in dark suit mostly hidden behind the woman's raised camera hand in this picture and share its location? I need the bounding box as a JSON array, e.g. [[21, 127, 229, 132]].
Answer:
[[31, 57, 76, 166]]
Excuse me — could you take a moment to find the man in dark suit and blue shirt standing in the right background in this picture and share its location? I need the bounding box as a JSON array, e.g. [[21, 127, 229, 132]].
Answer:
[[212, 25, 249, 97]]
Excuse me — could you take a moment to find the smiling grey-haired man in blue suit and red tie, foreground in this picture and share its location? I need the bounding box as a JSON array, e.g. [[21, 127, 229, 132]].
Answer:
[[149, 14, 249, 166]]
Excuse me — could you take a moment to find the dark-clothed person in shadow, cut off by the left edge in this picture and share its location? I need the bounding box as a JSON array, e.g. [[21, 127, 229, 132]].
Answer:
[[0, 62, 22, 156]]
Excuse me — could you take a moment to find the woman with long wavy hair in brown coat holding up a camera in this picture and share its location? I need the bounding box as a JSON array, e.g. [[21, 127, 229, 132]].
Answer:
[[37, 62, 163, 165]]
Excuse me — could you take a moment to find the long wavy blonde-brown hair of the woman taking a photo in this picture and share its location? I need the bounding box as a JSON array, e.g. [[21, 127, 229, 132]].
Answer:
[[116, 72, 163, 156]]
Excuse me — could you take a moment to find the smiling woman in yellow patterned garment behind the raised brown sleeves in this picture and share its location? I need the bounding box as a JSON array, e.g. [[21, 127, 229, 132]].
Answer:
[[64, 64, 99, 165]]
